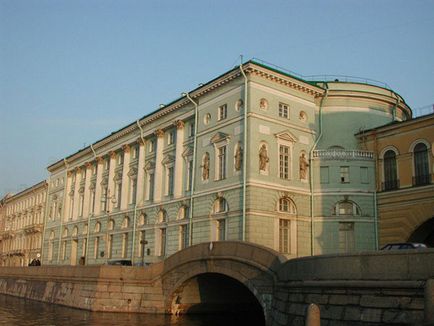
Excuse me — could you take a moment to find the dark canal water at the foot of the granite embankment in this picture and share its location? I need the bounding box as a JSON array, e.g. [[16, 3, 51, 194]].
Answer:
[[0, 294, 262, 326]]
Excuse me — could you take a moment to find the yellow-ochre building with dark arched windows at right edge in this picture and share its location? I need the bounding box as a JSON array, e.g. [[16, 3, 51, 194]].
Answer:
[[357, 114, 434, 247]]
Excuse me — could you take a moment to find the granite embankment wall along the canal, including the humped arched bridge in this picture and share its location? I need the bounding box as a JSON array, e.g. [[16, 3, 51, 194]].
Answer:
[[0, 241, 434, 326]]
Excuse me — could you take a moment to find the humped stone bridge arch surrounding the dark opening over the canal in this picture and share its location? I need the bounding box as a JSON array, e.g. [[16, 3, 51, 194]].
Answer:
[[162, 241, 286, 320]]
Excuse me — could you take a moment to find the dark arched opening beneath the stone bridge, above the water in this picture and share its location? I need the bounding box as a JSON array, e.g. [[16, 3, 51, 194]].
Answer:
[[172, 273, 265, 325]]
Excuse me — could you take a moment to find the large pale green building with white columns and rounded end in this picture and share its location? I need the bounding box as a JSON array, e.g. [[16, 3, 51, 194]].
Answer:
[[43, 61, 411, 265]]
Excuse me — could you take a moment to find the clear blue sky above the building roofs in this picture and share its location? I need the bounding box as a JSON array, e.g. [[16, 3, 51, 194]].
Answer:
[[0, 0, 434, 195]]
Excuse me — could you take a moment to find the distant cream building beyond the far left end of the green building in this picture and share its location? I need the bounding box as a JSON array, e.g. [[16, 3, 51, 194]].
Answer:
[[0, 181, 47, 266]]
